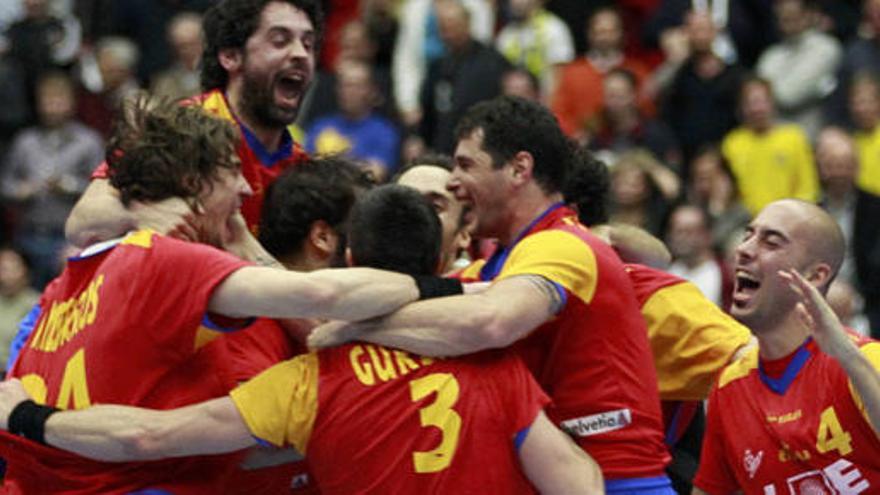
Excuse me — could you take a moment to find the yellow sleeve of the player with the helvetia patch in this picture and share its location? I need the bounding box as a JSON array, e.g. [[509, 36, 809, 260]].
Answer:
[[495, 230, 598, 303]]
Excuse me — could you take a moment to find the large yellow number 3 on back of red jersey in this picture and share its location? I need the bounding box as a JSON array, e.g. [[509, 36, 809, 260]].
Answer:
[[409, 373, 461, 473]]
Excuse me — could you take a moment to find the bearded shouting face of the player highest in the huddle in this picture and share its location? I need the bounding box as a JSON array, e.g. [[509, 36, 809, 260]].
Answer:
[[234, 2, 316, 128]]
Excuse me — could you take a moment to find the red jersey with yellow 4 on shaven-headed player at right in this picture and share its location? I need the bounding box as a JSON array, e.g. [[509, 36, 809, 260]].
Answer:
[[694, 334, 880, 495]]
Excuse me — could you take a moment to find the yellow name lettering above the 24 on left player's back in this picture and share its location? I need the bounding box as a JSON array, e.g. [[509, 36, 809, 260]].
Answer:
[[30, 274, 104, 352]]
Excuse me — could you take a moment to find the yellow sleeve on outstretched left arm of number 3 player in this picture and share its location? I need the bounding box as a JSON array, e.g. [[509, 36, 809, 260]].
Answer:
[[230, 352, 318, 453]]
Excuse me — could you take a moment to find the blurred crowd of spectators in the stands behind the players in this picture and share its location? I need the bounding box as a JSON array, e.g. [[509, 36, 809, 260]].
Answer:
[[0, 0, 880, 352]]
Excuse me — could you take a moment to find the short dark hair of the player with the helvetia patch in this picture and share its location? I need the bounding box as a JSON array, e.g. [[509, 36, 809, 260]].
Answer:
[[455, 96, 571, 193]]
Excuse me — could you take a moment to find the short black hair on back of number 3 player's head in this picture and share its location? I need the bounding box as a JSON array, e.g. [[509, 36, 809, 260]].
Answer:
[[348, 184, 442, 275]]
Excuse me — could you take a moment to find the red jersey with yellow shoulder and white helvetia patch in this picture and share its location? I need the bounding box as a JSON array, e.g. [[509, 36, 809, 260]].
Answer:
[[462, 205, 669, 479]]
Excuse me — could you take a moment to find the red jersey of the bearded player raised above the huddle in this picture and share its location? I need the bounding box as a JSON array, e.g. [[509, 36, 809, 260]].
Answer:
[[92, 89, 307, 232]]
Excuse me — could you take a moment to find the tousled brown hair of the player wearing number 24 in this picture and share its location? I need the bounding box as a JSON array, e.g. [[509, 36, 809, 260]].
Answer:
[[106, 95, 239, 205]]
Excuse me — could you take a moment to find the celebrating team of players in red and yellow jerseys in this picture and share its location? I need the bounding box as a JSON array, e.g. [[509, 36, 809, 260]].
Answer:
[[0, 0, 880, 495]]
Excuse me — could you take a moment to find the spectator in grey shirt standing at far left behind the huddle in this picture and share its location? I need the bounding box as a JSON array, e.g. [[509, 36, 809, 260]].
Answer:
[[2, 73, 104, 287]]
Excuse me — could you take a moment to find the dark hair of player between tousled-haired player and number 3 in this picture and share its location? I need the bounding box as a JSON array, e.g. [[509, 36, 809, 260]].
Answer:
[[259, 156, 373, 257]]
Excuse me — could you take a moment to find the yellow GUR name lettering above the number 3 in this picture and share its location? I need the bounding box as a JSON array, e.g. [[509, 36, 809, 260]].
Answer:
[[348, 344, 434, 387]]
